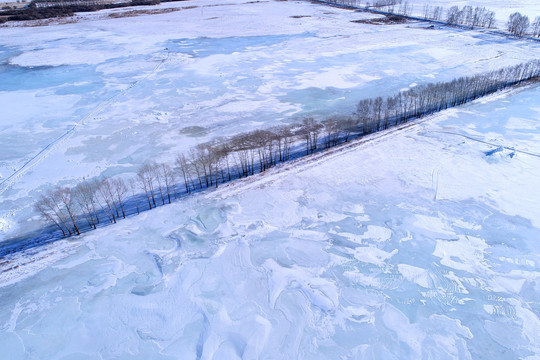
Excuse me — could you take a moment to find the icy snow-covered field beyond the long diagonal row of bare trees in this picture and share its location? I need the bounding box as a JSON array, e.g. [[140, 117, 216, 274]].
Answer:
[[0, 0, 540, 238]]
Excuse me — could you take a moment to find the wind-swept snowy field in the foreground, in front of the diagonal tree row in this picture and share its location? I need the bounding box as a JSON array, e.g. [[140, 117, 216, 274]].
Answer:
[[0, 81, 540, 360]]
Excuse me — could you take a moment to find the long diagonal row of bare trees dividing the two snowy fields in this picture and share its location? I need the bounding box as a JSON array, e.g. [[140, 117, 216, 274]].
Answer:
[[35, 60, 540, 236]]
